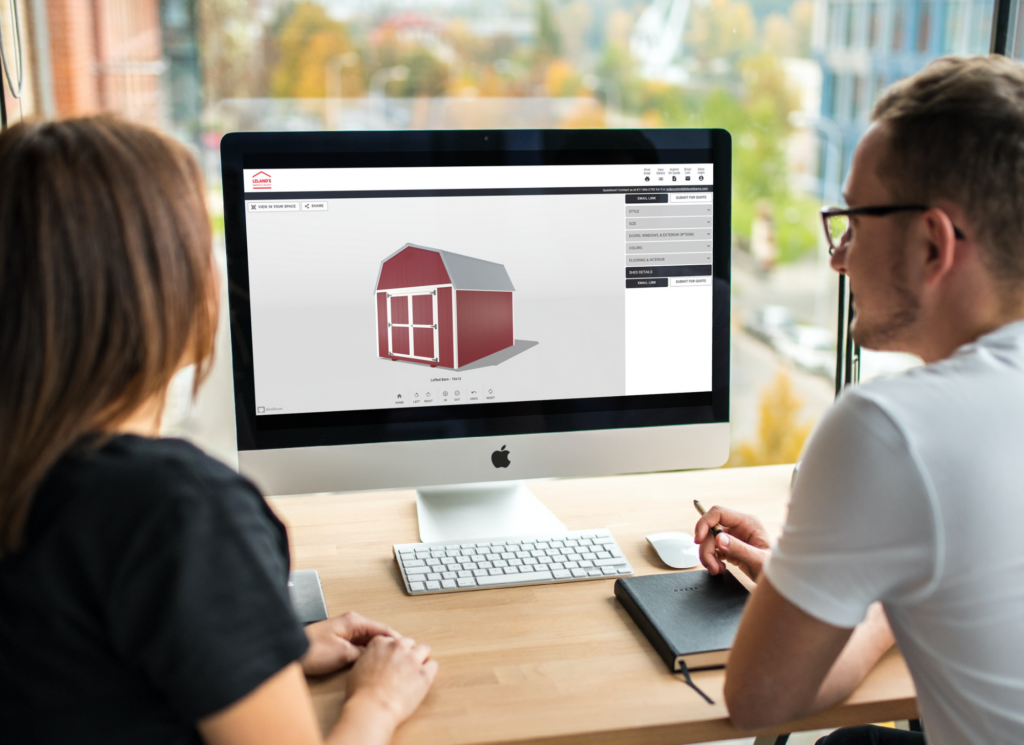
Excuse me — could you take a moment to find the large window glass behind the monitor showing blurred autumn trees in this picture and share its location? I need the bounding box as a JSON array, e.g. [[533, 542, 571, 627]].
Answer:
[[0, 0, 991, 465]]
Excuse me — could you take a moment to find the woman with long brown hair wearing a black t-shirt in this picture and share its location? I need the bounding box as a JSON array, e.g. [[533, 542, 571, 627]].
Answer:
[[0, 118, 437, 745]]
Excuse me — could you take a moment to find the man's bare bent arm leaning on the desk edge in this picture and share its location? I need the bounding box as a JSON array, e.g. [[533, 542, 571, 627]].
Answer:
[[725, 576, 893, 730]]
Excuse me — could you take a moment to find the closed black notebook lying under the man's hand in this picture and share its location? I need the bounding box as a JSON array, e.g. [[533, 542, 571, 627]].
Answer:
[[615, 570, 750, 672]]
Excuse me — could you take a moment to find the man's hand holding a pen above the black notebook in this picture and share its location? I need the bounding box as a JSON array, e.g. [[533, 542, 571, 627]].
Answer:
[[693, 506, 771, 582]]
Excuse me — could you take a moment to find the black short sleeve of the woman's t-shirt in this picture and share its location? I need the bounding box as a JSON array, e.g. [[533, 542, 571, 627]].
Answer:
[[105, 454, 307, 721]]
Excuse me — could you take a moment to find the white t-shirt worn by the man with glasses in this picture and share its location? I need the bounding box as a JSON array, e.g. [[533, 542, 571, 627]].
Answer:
[[765, 321, 1024, 745]]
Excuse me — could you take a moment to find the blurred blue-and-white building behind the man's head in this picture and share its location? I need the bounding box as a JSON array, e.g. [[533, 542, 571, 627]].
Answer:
[[812, 0, 992, 181]]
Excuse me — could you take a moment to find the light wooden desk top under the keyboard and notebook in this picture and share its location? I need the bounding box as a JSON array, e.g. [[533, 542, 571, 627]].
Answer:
[[271, 466, 918, 745]]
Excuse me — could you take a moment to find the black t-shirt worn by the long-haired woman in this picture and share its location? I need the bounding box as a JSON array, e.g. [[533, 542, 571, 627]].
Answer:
[[0, 435, 307, 745]]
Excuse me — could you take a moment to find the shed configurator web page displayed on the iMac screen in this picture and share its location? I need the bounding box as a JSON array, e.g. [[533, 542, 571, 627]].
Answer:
[[244, 163, 715, 415]]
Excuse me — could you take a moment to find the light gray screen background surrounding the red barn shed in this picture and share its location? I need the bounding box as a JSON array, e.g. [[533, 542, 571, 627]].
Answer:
[[246, 194, 626, 414]]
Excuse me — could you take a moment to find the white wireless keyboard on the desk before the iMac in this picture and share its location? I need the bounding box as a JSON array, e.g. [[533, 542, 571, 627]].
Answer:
[[394, 530, 633, 595]]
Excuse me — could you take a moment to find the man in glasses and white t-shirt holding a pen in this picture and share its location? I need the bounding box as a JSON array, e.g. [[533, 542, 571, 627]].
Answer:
[[694, 56, 1024, 745]]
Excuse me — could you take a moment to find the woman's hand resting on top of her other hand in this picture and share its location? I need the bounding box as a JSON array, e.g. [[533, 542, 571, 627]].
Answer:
[[342, 636, 437, 727]]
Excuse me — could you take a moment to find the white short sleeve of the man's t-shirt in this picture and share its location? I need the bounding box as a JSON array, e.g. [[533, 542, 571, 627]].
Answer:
[[765, 392, 936, 628]]
